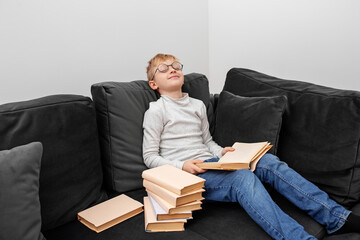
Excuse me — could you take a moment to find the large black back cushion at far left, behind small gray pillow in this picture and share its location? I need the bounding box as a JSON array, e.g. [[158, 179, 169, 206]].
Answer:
[[0, 95, 104, 230]]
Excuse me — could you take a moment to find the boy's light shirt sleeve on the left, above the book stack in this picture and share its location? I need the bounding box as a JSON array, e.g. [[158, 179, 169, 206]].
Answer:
[[143, 105, 184, 169]]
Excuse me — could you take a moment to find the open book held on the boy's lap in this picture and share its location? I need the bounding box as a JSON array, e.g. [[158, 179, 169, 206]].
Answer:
[[196, 142, 272, 171]]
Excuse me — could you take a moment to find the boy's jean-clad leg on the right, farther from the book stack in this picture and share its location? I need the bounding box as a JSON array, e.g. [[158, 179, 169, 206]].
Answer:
[[254, 154, 350, 233]]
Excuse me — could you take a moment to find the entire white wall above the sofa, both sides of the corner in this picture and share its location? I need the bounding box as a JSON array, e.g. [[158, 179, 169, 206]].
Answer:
[[0, 0, 360, 104]]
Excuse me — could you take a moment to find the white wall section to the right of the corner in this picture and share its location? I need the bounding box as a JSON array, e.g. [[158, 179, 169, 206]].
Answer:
[[209, 0, 360, 92]]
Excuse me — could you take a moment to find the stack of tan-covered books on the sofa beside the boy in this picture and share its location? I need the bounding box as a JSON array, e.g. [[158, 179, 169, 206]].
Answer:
[[142, 165, 205, 232]]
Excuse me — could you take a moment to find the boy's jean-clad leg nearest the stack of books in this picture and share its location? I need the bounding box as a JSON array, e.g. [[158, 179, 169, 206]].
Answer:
[[198, 170, 315, 239]]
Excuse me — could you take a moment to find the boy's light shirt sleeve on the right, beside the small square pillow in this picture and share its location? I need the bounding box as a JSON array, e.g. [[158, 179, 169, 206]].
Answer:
[[201, 104, 223, 158]]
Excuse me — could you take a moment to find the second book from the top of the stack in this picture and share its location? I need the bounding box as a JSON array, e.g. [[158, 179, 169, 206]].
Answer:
[[143, 179, 205, 207]]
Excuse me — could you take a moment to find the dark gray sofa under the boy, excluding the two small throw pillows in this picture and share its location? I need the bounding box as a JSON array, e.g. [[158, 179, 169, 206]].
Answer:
[[0, 68, 360, 240]]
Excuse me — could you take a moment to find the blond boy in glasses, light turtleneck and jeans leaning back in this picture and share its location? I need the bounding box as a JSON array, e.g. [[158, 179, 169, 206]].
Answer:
[[143, 54, 360, 239]]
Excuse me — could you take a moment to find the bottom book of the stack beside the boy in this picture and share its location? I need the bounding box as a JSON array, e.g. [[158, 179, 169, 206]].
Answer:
[[144, 197, 187, 232]]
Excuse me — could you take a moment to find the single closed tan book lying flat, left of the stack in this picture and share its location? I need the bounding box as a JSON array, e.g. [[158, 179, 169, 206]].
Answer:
[[77, 194, 143, 233]]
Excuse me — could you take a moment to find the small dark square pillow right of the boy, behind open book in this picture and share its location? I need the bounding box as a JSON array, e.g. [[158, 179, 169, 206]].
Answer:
[[213, 91, 287, 154]]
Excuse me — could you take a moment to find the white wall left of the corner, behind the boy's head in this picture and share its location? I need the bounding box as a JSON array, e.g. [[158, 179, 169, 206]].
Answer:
[[0, 0, 209, 104]]
